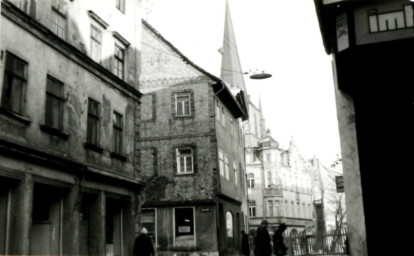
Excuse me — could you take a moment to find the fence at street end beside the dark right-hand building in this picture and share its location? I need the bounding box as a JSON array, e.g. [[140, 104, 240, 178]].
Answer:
[[284, 229, 347, 256]]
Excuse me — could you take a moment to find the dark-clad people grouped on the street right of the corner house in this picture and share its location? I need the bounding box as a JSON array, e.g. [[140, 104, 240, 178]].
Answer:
[[242, 220, 288, 256]]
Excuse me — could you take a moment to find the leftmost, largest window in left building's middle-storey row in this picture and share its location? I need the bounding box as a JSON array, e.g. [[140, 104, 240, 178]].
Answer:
[[1, 52, 27, 114]]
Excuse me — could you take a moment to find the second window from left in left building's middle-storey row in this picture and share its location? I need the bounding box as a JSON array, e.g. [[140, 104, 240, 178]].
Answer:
[[45, 76, 64, 130]]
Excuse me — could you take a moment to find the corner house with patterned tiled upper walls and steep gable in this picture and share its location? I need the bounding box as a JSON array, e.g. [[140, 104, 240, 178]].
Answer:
[[139, 21, 247, 255]]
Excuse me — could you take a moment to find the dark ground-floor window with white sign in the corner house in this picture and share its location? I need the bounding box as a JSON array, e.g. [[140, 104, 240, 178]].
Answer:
[[174, 208, 195, 247]]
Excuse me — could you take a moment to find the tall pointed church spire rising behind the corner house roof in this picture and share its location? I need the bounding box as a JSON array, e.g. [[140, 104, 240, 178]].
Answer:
[[220, 0, 247, 93]]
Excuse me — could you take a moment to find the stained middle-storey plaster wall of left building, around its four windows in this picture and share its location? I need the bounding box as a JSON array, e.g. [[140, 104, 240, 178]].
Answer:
[[0, 6, 139, 178]]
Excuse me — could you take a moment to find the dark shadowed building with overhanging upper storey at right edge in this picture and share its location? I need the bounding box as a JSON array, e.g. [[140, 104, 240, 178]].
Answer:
[[314, 0, 414, 256]]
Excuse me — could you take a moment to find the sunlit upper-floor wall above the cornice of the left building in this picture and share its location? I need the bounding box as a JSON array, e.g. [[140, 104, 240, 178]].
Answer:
[[4, 0, 142, 89]]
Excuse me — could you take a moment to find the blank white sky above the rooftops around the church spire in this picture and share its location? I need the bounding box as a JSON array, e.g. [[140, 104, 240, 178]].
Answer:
[[144, 0, 340, 166]]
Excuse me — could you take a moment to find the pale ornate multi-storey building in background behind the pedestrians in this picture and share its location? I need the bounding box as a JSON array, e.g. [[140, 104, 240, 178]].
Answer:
[[244, 99, 314, 234]]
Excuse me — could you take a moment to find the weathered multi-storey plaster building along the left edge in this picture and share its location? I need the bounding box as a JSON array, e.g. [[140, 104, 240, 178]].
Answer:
[[0, 0, 142, 255]]
